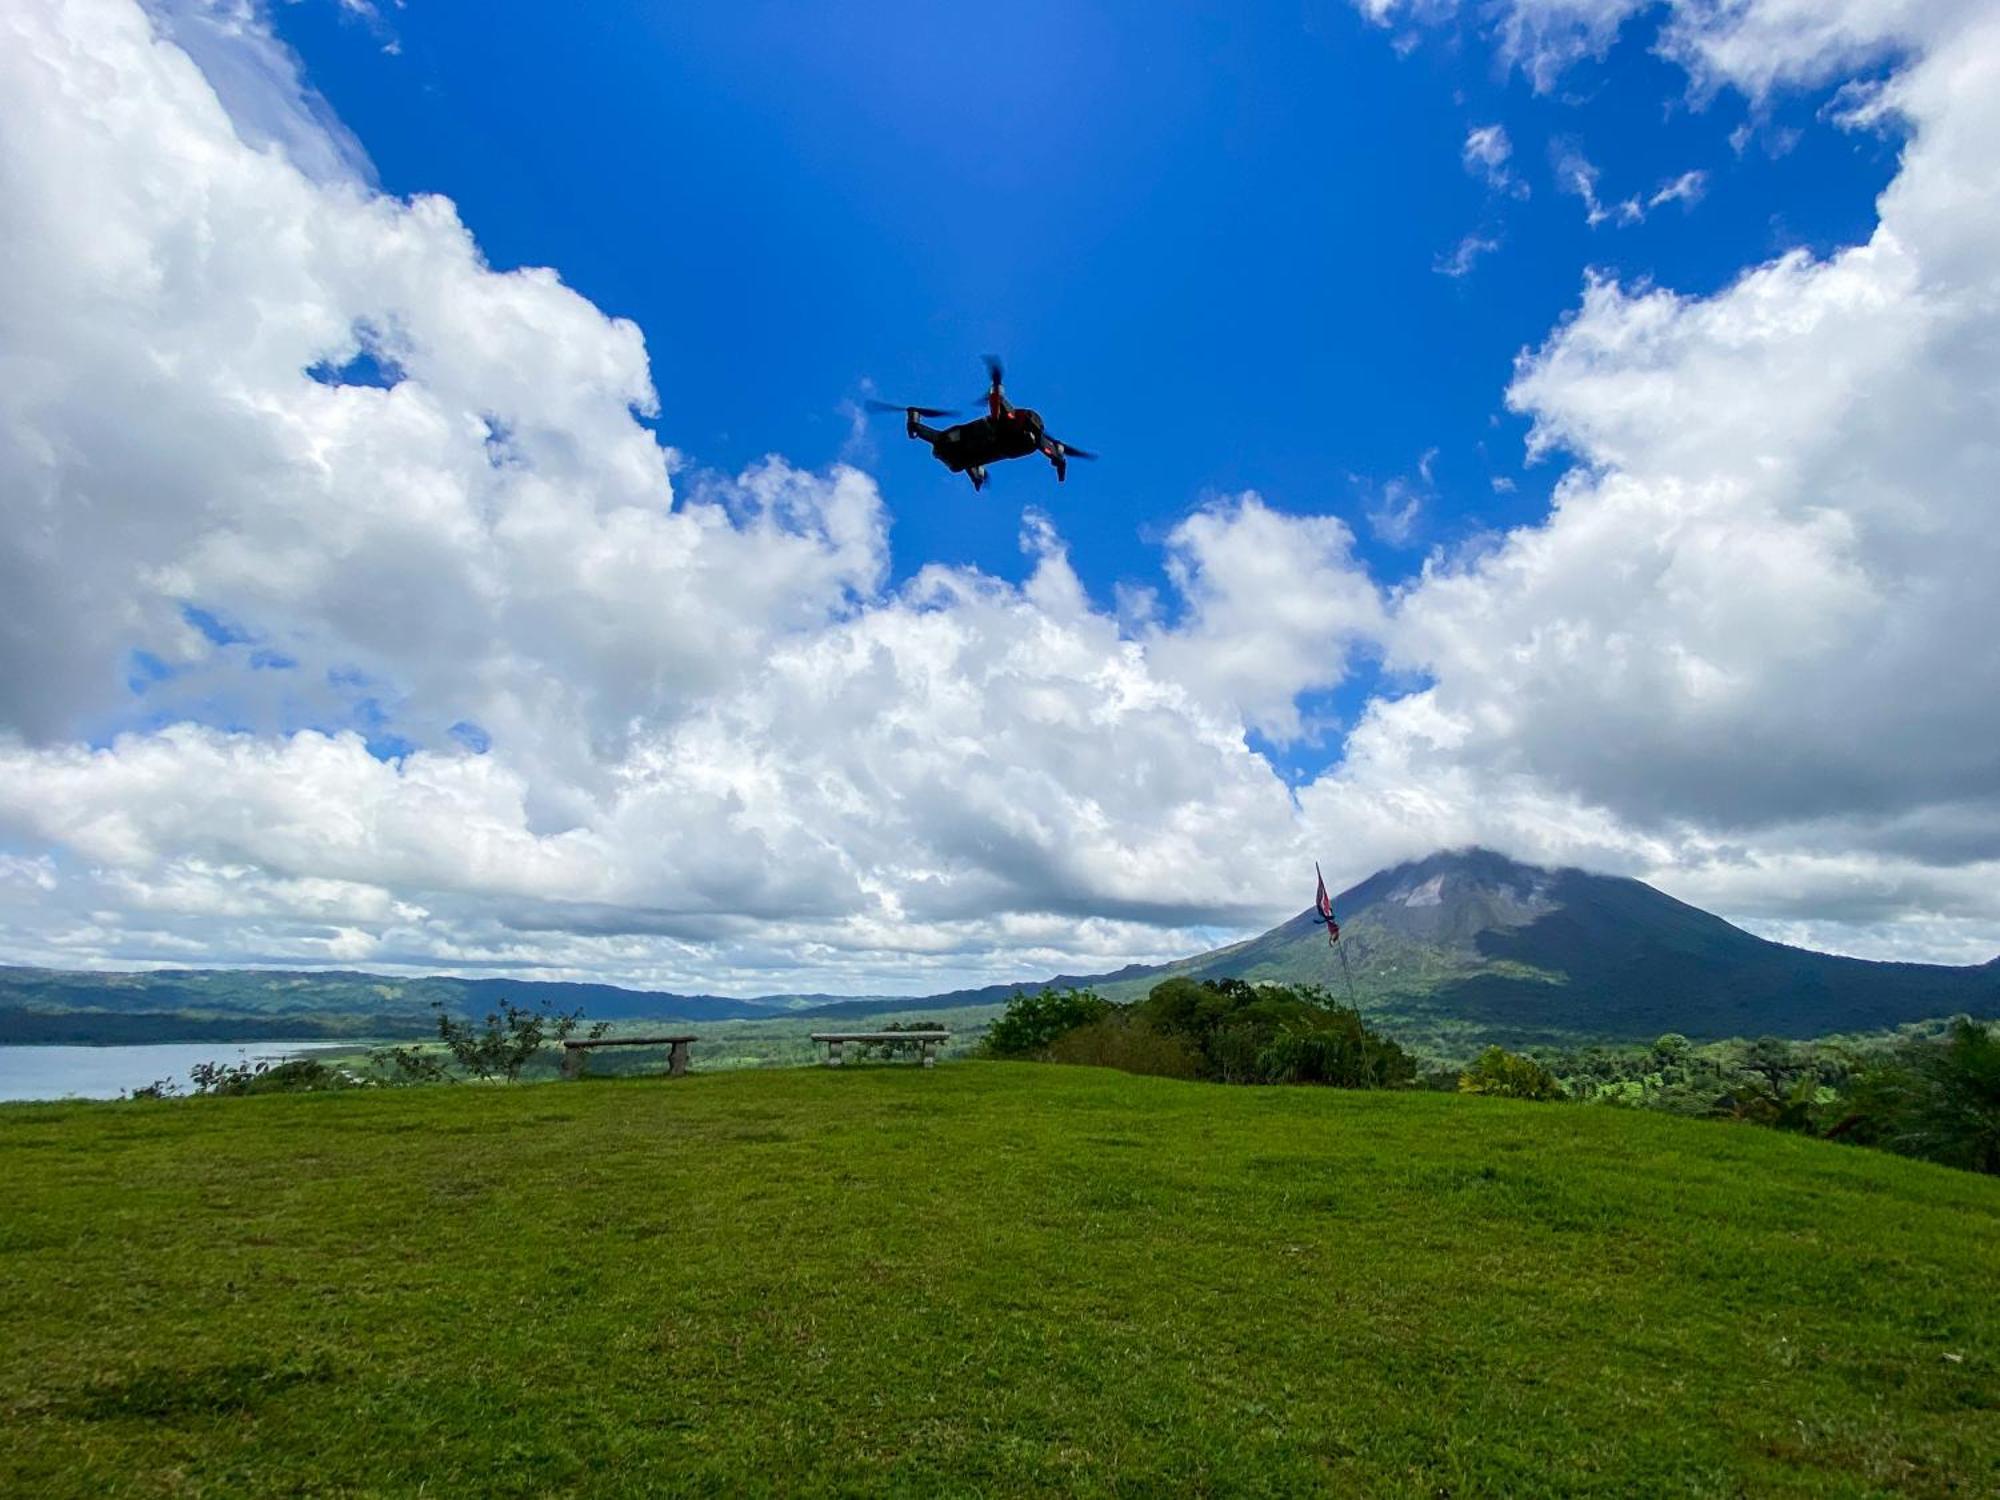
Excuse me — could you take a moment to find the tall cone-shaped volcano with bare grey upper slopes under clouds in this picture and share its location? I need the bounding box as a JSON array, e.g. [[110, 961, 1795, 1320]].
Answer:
[[936, 848, 2000, 1042]]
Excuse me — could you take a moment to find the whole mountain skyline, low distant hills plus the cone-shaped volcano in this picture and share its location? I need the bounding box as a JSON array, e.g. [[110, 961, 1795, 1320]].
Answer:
[[0, 848, 2000, 1042]]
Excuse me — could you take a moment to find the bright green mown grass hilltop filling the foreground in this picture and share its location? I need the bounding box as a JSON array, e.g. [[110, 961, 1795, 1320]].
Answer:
[[0, 1062, 2000, 1496]]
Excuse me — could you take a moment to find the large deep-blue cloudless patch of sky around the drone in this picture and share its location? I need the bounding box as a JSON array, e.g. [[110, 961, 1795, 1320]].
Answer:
[[274, 0, 1896, 600]]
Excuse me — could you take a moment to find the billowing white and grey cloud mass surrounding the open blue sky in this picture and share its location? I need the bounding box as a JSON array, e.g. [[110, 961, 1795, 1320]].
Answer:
[[0, 0, 2000, 992]]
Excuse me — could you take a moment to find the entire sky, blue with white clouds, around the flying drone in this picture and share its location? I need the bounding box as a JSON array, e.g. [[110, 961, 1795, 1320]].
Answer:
[[0, 0, 2000, 992]]
